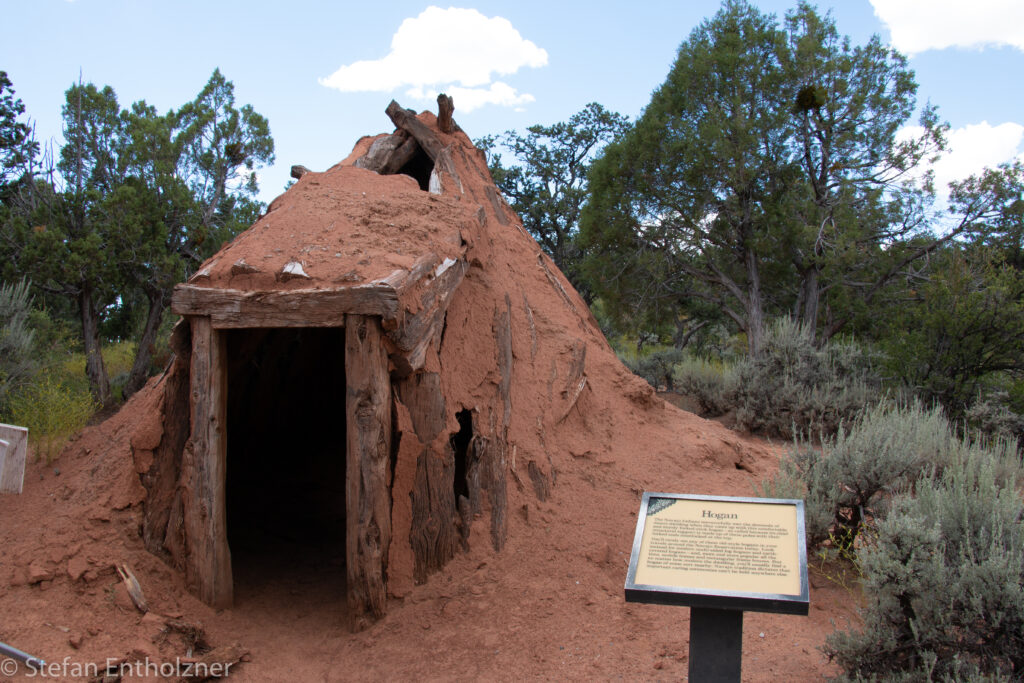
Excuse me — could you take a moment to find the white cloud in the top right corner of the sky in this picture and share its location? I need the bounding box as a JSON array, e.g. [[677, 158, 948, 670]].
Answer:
[[870, 0, 1024, 54]]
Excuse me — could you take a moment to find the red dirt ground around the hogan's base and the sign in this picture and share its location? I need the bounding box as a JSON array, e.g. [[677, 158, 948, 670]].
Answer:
[[0, 397, 856, 681]]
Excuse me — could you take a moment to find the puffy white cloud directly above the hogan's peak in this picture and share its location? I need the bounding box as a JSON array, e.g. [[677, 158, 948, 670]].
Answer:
[[319, 7, 548, 112]]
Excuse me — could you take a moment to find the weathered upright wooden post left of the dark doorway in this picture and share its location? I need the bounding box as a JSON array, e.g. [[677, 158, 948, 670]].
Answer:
[[181, 316, 233, 608]]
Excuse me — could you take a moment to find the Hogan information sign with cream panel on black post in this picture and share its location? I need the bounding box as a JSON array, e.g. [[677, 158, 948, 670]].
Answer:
[[626, 493, 810, 683]]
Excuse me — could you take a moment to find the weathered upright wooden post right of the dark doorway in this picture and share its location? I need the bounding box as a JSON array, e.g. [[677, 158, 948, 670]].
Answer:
[[345, 315, 391, 628]]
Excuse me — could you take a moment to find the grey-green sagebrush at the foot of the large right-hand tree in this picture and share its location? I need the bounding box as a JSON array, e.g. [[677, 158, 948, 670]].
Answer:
[[732, 318, 880, 438]]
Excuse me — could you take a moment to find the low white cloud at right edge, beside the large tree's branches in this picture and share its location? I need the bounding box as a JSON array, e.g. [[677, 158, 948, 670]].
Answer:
[[899, 121, 1024, 192]]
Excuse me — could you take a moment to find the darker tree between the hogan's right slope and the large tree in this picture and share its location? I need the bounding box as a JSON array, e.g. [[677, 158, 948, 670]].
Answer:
[[476, 102, 629, 300]]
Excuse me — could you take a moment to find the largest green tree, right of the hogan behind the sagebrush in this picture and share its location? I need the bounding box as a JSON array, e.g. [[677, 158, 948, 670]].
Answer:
[[581, 0, 942, 353]]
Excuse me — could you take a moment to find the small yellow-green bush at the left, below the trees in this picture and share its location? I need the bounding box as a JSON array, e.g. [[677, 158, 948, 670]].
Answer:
[[8, 373, 98, 462]]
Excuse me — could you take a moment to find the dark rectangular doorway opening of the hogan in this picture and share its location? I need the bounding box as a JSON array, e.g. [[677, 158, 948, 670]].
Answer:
[[226, 328, 346, 610]]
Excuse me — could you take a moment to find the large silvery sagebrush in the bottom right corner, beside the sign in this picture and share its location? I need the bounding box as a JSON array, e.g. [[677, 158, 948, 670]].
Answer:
[[825, 440, 1024, 681]]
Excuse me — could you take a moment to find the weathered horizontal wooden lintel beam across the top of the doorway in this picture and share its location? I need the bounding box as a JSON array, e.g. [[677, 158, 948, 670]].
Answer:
[[171, 281, 398, 329]]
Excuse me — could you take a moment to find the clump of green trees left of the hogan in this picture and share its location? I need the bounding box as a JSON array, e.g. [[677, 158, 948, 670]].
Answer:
[[0, 70, 273, 403]]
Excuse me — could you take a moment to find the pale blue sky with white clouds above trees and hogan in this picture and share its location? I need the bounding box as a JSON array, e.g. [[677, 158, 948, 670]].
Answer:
[[0, 0, 1024, 201]]
